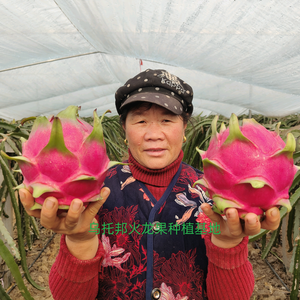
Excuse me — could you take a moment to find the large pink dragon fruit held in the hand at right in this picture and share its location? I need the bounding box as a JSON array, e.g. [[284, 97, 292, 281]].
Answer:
[[195, 114, 298, 218]]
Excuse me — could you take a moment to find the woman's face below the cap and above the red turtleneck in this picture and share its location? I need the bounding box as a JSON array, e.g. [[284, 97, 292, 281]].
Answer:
[[124, 104, 186, 169]]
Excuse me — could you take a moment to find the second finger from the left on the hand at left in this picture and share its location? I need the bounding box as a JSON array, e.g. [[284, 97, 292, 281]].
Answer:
[[41, 197, 61, 232]]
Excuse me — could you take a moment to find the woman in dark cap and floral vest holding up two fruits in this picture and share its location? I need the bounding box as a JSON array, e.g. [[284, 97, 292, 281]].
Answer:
[[20, 70, 280, 300]]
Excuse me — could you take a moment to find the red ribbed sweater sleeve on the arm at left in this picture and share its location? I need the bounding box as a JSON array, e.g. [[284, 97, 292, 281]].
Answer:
[[49, 235, 104, 300]]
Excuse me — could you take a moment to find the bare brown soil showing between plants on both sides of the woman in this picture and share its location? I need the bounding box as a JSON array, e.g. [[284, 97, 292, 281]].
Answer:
[[6, 229, 300, 300]]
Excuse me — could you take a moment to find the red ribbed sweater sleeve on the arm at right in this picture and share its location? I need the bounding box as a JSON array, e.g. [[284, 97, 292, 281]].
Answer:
[[204, 234, 254, 300]]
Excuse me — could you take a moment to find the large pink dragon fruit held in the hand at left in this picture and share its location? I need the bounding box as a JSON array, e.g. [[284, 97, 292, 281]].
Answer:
[[2, 106, 111, 209]]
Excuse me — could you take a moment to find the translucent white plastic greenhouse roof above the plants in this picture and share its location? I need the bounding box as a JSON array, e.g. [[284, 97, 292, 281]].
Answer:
[[0, 0, 300, 120]]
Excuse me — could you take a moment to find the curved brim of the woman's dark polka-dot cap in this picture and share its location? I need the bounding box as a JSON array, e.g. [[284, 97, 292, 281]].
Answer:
[[120, 92, 183, 115]]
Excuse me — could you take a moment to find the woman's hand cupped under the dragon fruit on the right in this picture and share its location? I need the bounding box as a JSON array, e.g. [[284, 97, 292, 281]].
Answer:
[[201, 203, 280, 248]]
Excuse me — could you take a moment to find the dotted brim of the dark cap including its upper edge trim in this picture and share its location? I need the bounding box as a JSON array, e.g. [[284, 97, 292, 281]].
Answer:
[[120, 87, 187, 115]]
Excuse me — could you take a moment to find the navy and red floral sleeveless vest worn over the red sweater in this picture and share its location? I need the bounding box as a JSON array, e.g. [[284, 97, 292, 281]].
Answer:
[[98, 163, 210, 300]]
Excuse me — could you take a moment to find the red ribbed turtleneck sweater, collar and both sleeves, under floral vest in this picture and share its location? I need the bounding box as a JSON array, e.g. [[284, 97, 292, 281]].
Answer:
[[49, 152, 254, 300]]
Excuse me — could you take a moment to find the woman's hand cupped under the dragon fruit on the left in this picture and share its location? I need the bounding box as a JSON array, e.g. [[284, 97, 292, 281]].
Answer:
[[19, 188, 110, 259]]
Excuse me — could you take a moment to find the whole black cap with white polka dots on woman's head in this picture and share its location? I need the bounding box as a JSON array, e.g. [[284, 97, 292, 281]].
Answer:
[[115, 69, 193, 115]]
